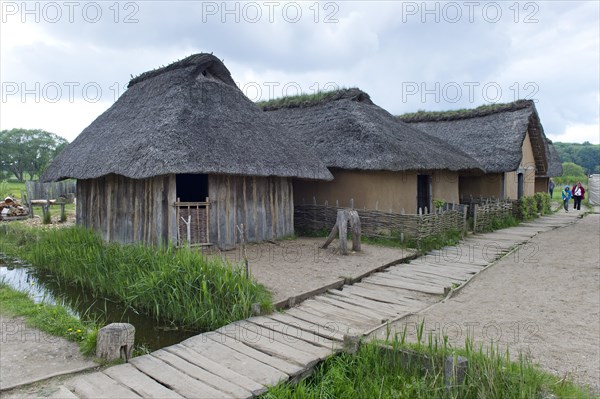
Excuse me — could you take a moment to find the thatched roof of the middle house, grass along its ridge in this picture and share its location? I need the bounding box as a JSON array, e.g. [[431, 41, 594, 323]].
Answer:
[[263, 89, 481, 172]]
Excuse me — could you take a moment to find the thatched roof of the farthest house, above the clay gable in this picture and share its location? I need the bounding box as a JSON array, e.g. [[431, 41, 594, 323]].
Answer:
[[398, 100, 548, 175]]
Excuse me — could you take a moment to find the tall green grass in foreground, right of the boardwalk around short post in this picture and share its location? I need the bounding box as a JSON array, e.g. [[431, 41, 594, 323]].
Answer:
[[261, 329, 591, 399]]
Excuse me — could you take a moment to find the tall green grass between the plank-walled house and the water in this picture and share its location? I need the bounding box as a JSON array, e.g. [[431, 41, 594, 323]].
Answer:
[[0, 225, 272, 331]]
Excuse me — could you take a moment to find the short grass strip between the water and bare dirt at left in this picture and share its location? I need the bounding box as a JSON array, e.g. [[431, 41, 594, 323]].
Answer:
[[0, 282, 99, 355]]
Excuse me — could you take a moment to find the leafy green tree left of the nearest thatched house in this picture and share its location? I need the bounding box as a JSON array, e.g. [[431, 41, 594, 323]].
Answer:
[[0, 129, 68, 181]]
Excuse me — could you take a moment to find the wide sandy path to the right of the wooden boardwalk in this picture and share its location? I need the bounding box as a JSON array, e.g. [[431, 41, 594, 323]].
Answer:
[[372, 214, 600, 392]]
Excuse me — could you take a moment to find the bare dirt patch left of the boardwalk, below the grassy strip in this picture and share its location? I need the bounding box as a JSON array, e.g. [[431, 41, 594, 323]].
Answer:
[[0, 314, 97, 390]]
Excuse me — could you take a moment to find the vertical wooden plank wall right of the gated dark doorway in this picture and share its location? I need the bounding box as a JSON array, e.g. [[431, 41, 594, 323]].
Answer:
[[208, 175, 294, 249]]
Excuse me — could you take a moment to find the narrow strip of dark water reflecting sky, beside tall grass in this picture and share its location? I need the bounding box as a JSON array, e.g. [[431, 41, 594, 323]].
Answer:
[[0, 253, 200, 350]]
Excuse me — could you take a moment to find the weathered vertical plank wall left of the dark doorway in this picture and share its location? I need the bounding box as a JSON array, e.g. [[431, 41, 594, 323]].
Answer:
[[77, 175, 177, 245]]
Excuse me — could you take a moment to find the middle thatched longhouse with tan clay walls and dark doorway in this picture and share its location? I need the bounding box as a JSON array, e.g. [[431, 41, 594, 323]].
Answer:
[[262, 89, 483, 213]]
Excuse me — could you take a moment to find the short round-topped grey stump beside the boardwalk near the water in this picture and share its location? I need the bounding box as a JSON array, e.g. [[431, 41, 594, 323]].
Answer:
[[96, 323, 135, 362]]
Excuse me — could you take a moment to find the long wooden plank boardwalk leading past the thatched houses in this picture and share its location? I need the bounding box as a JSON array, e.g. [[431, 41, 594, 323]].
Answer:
[[52, 213, 576, 399]]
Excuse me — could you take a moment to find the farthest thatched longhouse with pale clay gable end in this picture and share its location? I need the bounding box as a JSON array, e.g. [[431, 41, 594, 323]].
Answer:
[[399, 100, 548, 199]]
